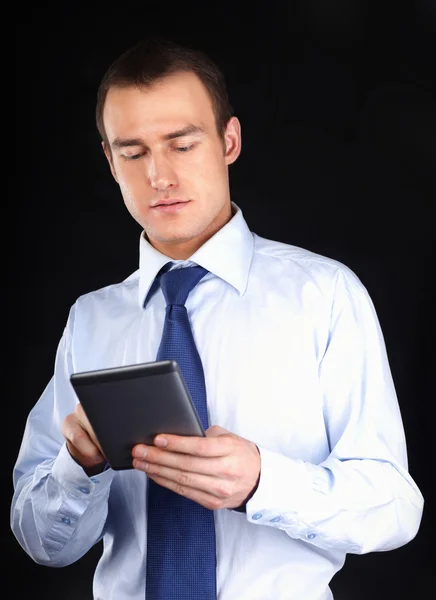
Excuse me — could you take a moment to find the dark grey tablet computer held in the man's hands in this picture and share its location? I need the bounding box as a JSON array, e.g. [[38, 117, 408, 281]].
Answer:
[[70, 360, 205, 470]]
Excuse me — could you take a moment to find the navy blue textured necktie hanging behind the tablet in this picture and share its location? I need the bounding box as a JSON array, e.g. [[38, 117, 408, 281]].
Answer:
[[146, 266, 216, 600]]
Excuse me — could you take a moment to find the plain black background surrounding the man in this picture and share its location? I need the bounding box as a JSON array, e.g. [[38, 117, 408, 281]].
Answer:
[[11, 0, 436, 600]]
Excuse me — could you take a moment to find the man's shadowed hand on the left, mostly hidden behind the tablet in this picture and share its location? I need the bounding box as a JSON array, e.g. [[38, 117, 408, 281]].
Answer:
[[62, 403, 106, 474]]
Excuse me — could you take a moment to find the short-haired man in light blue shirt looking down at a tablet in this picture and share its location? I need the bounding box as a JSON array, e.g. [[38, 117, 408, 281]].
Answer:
[[11, 37, 423, 600]]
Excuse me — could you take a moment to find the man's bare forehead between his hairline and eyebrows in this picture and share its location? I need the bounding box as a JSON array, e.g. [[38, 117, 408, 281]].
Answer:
[[103, 73, 215, 141]]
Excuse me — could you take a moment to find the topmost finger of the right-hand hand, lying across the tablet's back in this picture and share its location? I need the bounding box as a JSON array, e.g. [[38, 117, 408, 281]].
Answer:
[[154, 433, 232, 457]]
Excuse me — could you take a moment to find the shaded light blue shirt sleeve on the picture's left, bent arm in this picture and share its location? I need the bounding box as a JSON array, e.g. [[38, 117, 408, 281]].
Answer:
[[11, 306, 115, 567]]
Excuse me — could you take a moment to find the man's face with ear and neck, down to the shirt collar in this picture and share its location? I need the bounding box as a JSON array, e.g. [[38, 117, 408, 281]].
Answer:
[[103, 73, 241, 259]]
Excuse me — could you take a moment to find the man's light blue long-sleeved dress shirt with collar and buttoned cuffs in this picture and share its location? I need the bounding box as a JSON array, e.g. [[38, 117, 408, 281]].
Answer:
[[11, 204, 423, 600]]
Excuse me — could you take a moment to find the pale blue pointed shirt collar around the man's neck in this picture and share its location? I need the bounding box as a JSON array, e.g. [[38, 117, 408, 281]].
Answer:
[[138, 202, 254, 307]]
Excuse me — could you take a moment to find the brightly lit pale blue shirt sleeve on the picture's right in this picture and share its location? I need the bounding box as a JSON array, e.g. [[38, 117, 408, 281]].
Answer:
[[247, 267, 424, 554]]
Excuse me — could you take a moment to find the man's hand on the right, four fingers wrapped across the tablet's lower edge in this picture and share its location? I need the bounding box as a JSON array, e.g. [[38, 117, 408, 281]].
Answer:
[[132, 425, 260, 510]]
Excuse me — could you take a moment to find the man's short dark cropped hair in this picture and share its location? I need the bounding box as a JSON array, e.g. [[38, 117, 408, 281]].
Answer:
[[96, 38, 233, 144]]
